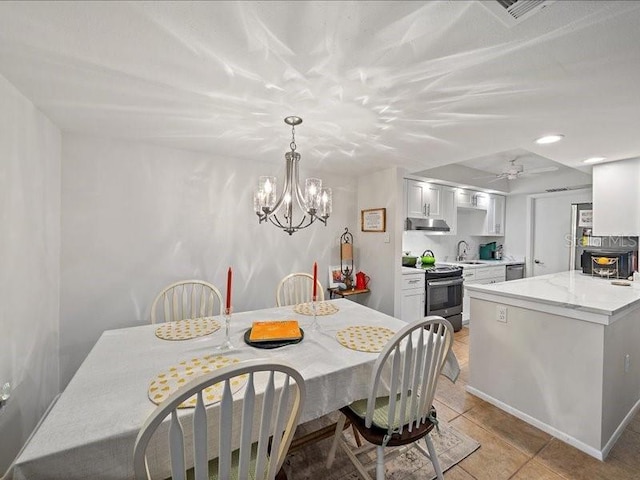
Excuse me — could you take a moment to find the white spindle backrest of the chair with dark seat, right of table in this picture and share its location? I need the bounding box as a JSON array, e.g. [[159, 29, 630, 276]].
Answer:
[[365, 316, 453, 435]]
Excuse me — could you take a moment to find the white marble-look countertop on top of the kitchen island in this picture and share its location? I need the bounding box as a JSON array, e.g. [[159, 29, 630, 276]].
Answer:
[[465, 270, 640, 316]]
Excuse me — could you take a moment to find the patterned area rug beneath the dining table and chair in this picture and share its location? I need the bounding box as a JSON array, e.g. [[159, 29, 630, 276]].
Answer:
[[284, 416, 480, 480]]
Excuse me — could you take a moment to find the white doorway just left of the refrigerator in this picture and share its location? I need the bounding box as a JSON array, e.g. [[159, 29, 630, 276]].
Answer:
[[526, 189, 592, 277]]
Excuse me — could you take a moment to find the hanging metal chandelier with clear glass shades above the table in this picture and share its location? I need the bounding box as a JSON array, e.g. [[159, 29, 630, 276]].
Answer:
[[253, 116, 331, 235]]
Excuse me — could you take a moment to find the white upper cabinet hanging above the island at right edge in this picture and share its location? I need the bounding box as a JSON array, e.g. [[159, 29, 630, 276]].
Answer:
[[593, 158, 640, 237]]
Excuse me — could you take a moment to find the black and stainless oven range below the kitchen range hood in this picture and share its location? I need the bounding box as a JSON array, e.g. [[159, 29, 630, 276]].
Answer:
[[424, 265, 464, 332]]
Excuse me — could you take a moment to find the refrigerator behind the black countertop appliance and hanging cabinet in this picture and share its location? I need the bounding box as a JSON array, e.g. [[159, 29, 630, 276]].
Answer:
[[569, 203, 638, 270]]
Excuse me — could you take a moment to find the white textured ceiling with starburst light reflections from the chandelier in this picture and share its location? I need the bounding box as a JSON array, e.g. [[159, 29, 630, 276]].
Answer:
[[0, 0, 640, 175]]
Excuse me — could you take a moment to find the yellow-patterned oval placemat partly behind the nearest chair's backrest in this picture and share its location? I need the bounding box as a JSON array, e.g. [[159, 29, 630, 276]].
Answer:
[[148, 355, 247, 408]]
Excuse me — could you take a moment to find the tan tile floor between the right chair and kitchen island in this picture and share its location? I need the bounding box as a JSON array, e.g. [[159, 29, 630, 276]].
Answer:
[[435, 327, 640, 480]]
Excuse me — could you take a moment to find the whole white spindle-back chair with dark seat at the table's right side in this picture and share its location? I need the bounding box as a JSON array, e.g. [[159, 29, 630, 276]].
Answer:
[[327, 316, 453, 480]]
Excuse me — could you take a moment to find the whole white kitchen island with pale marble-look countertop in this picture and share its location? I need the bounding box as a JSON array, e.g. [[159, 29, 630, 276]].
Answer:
[[466, 271, 640, 460]]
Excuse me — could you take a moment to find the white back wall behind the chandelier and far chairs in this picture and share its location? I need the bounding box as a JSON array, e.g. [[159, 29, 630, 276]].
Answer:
[[60, 135, 360, 387]]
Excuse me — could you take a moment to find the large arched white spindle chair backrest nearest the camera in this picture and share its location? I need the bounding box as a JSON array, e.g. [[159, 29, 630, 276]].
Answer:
[[133, 360, 305, 480]]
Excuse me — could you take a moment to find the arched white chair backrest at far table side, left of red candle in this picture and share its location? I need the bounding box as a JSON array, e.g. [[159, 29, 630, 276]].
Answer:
[[151, 280, 223, 323]]
